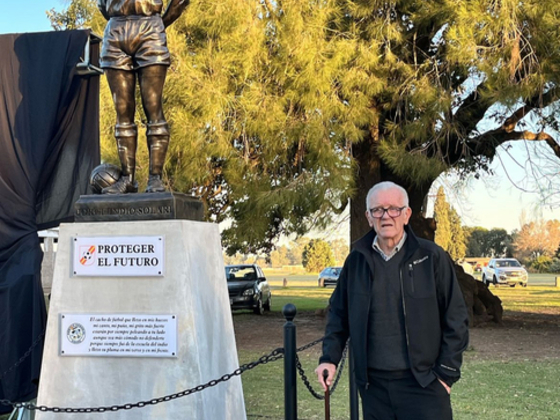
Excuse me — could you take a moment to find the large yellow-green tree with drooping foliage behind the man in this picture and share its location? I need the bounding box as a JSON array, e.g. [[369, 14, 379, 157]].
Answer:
[[53, 0, 560, 254]]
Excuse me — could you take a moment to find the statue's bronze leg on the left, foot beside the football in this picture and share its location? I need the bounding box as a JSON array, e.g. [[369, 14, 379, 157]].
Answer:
[[102, 69, 138, 194]]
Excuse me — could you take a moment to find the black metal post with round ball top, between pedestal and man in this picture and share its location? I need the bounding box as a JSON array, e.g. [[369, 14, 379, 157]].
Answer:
[[282, 303, 297, 420]]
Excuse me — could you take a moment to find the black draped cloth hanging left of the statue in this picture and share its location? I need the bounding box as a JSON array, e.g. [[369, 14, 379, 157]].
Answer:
[[0, 31, 99, 412]]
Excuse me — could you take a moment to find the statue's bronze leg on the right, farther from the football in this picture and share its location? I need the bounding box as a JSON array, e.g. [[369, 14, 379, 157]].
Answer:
[[138, 65, 169, 192]]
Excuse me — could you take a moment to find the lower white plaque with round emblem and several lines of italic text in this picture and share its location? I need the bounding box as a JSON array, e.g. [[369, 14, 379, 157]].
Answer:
[[60, 314, 177, 357]]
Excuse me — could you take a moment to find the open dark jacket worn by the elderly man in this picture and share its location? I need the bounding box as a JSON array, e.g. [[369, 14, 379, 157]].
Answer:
[[319, 226, 468, 387]]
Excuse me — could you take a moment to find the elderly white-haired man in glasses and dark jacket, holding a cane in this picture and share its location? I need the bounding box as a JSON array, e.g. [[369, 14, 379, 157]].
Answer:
[[316, 182, 468, 420]]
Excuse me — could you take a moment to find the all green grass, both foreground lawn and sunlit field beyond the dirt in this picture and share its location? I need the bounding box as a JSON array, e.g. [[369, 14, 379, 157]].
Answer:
[[0, 272, 560, 420]]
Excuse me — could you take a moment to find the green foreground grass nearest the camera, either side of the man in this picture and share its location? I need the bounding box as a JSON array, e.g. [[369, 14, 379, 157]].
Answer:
[[239, 352, 560, 420]]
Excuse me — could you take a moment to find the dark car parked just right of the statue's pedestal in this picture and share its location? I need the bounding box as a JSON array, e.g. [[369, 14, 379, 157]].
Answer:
[[226, 264, 272, 315]]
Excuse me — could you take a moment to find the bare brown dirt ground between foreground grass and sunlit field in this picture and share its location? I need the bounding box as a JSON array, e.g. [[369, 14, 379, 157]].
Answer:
[[233, 308, 560, 360]]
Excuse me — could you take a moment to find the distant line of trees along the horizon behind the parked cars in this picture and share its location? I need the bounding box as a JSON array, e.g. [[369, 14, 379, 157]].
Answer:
[[224, 187, 560, 273]]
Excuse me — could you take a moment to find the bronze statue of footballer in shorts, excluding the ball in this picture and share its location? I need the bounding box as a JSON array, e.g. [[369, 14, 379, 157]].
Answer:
[[97, 0, 189, 194]]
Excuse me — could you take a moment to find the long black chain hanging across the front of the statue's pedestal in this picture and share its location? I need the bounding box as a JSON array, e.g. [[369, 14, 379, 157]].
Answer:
[[0, 348, 284, 413]]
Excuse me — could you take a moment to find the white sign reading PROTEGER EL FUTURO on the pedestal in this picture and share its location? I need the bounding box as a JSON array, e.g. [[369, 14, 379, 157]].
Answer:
[[72, 236, 164, 277]]
